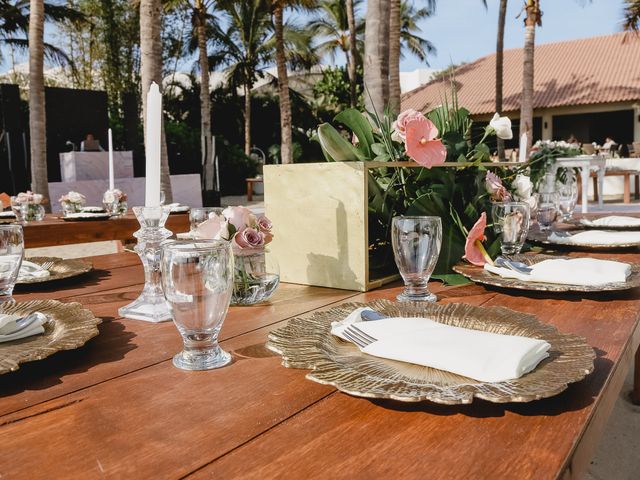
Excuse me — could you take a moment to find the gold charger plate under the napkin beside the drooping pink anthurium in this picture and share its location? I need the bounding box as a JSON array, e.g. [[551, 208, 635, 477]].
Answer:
[[453, 255, 640, 292]]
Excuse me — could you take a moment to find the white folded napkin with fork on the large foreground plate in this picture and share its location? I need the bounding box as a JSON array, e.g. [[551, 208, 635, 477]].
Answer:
[[331, 308, 550, 382]]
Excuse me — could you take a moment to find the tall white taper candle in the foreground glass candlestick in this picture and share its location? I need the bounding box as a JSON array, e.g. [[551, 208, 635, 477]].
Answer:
[[144, 82, 162, 207]]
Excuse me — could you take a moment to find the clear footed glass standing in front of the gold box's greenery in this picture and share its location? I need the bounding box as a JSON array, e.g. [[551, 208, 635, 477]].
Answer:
[[391, 217, 442, 302]]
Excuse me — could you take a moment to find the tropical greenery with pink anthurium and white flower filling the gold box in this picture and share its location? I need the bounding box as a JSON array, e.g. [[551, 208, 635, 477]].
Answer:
[[317, 92, 512, 279]]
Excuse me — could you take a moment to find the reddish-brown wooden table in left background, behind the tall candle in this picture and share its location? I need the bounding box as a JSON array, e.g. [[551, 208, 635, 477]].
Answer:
[[24, 213, 189, 248]]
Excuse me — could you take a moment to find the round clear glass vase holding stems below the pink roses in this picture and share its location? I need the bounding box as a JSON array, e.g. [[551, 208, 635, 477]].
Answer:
[[231, 248, 280, 305]]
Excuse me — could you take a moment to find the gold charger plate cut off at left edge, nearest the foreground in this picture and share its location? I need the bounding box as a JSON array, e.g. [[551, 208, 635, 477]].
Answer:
[[0, 300, 102, 375]]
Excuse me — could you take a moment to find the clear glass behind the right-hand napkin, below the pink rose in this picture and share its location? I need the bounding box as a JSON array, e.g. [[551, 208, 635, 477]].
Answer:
[[491, 202, 530, 255]]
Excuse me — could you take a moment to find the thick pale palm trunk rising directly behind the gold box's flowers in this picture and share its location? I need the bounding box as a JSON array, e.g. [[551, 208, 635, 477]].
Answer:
[[364, 0, 389, 115]]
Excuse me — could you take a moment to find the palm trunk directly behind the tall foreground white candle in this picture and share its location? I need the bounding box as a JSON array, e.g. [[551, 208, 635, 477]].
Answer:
[[140, 0, 173, 203]]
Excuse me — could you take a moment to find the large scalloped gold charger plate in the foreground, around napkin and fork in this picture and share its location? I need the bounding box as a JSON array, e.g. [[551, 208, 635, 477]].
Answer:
[[267, 300, 595, 405]]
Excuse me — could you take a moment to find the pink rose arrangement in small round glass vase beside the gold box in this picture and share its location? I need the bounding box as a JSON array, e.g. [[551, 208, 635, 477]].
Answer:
[[194, 207, 280, 305]]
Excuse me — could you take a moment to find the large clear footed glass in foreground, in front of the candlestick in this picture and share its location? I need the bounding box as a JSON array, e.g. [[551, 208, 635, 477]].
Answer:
[[161, 240, 233, 370]]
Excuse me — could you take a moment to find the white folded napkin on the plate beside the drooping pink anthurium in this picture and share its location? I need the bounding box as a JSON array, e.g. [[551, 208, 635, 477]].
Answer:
[[484, 258, 631, 286]]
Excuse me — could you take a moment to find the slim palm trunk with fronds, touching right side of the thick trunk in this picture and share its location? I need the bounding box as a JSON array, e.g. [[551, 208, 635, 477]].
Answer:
[[389, 0, 436, 113]]
